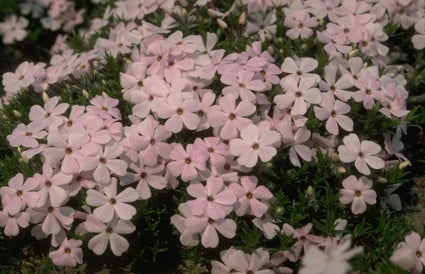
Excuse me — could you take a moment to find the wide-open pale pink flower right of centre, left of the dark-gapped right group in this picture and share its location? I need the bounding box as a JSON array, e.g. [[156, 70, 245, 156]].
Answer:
[[274, 77, 322, 115]]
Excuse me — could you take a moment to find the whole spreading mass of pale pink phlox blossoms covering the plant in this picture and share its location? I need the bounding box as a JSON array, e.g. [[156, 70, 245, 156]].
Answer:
[[0, 0, 425, 273]]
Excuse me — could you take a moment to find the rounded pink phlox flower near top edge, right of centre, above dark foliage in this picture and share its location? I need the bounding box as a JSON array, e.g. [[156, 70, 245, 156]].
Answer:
[[283, 9, 318, 40]]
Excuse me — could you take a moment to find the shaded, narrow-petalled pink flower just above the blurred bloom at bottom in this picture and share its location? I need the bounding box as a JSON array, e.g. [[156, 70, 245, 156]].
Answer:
[[282, 223, 325, 262]]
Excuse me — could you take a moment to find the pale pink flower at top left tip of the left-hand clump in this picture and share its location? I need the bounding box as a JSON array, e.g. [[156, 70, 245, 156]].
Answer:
[[29, 96, 69, 128]]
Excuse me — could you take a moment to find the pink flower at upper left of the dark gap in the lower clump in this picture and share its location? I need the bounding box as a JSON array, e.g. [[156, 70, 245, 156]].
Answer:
[[120, 155, 167, 200]]
